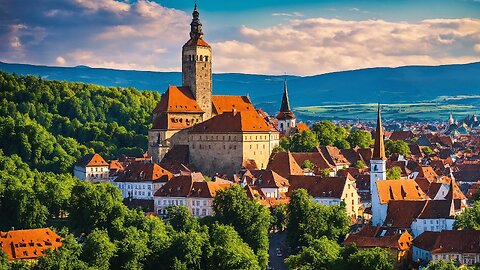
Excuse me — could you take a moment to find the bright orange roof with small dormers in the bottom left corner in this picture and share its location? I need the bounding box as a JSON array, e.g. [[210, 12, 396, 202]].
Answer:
[[0, 228, 62, 260]]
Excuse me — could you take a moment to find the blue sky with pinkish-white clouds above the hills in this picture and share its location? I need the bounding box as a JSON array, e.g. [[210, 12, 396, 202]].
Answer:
[[0, 0, 480, 76]]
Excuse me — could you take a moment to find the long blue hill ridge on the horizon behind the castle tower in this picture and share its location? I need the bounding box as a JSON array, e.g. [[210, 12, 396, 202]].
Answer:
[[0, 62, 480, 119]]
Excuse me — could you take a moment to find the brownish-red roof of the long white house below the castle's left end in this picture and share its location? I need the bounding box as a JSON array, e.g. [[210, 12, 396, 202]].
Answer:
[[115, 161, 172, 182]]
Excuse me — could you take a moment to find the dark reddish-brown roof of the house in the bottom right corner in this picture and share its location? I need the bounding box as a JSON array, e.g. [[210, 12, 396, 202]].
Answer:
[[413, 230, 480, 254]]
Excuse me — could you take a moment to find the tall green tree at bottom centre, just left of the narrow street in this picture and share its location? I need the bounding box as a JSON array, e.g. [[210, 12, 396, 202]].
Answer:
[[213, 186, 271, 269]]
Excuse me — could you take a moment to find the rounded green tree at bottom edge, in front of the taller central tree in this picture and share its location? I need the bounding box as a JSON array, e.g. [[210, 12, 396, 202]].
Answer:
[[204, 224, 260, 270]]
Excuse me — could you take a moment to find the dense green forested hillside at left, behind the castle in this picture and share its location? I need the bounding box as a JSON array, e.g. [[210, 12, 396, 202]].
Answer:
[[0, 72, 160, 172]]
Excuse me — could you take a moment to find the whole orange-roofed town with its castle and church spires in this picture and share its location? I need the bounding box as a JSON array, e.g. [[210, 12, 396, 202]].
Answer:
[[0, 2, 480, 269]]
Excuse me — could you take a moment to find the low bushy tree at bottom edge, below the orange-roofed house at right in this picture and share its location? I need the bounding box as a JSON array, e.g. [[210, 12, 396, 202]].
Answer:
[[348, 247, 395, 270]]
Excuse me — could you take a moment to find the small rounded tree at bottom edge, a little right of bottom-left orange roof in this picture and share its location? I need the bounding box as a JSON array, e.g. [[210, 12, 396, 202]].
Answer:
[[81, 229, 116, 270]]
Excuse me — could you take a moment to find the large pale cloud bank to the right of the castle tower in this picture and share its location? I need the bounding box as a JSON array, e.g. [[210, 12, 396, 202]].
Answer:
[[212, 18, 480, 75]]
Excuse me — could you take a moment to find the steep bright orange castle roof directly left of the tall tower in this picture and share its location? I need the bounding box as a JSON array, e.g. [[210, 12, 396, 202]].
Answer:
[[153, 86, 203, 114]]
